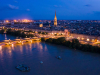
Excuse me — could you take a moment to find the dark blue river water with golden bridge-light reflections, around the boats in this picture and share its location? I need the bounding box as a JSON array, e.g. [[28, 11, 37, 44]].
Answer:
[[0, 35, 100, 75]]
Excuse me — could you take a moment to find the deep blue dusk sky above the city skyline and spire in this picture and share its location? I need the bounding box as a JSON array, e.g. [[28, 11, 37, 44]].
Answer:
[[0, 0, 100, 20]]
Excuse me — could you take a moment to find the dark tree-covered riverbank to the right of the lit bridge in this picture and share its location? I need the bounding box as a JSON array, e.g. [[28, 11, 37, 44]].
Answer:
[[41, 37, 100, 53]]
